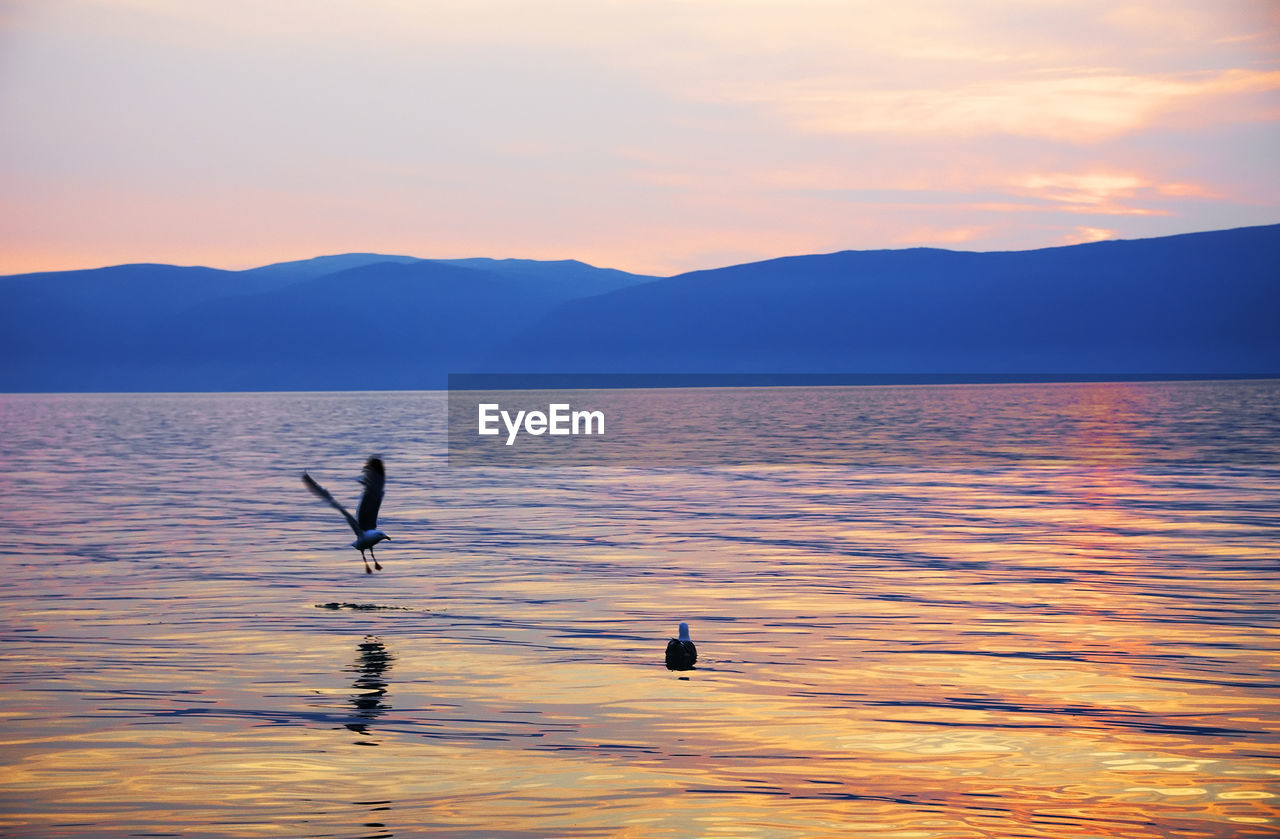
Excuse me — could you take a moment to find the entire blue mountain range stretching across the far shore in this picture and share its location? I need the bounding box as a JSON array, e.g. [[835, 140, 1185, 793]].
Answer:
[[0, 225, 1280, 391]]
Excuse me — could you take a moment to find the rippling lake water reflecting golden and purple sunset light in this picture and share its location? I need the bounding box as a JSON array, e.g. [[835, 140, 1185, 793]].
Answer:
[[0, 383, 1280, 839]]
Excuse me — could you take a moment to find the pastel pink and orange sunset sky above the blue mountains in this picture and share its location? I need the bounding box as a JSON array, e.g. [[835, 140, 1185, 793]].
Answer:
[[0, 0, 1280, 274]]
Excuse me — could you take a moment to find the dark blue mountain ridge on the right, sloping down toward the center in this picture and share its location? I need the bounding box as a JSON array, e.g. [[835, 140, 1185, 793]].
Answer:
[[488, 225, 1280, 374]]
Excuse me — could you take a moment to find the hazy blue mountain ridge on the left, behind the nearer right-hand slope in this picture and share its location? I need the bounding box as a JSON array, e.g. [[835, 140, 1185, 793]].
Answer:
[[0, 254, 654, 392]]
